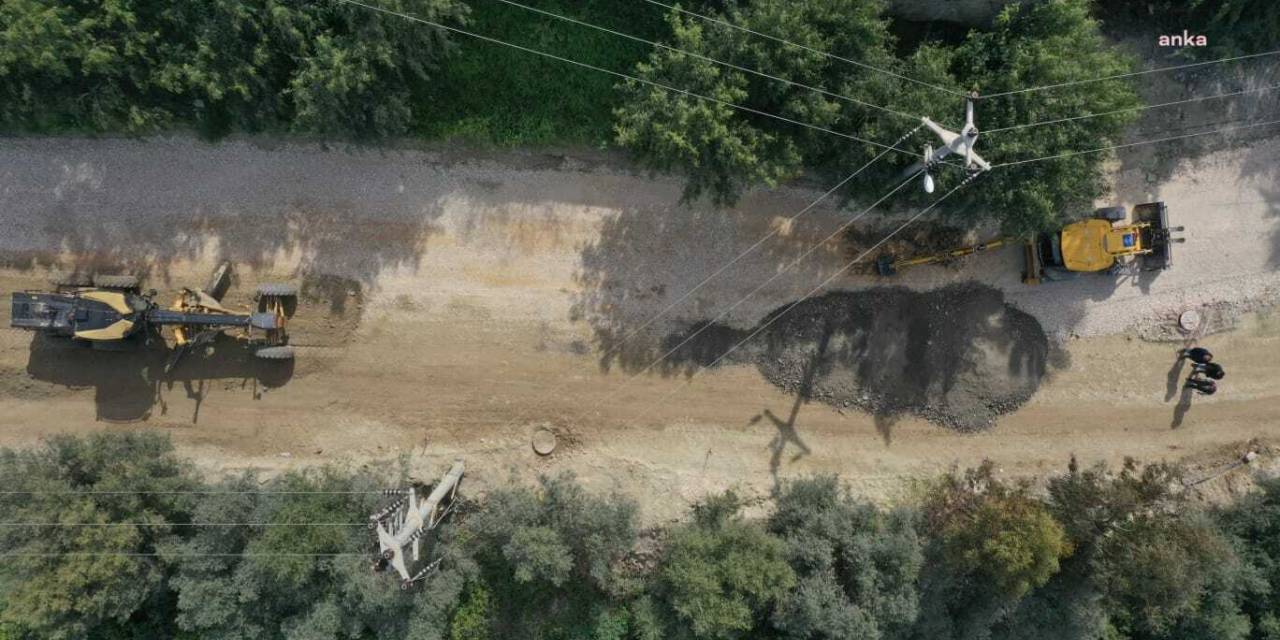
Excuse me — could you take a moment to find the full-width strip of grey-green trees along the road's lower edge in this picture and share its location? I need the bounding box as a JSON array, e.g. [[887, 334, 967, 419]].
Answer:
[[0, 434, 1280, 640]]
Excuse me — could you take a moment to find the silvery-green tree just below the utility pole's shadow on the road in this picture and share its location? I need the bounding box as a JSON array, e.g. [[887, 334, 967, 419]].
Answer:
[[768, 476, 923, 640]]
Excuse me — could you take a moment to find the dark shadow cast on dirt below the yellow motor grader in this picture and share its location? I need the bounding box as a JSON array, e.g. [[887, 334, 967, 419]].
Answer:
[[27, 334, 294, 424]]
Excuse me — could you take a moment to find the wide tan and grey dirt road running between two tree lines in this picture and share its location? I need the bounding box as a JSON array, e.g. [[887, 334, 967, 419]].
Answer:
[[0, 140, 1280, 518]]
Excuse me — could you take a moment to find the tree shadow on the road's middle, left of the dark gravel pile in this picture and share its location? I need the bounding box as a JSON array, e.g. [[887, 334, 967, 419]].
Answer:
[[570, 200, 860, 375]]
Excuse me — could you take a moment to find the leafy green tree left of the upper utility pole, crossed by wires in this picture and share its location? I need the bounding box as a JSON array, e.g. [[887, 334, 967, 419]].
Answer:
[[616, 0, 896, 205]]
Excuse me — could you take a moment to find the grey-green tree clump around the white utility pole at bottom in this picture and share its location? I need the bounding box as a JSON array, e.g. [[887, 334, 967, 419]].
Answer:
[[165, 468, 475, 640]]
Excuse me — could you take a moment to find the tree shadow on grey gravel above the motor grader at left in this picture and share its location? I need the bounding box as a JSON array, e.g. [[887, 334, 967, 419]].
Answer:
[[0, 142, 443, 287]]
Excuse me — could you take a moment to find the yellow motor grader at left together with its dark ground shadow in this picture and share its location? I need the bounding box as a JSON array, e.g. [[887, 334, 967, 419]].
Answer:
[[12, 264, 297, 421]]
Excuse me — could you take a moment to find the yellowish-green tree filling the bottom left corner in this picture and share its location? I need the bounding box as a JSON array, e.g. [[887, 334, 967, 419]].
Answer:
[[0, 433, 200, 640]]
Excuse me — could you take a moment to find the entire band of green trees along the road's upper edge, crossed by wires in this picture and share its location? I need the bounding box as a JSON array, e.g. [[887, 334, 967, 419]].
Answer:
[[0, 0, 1141, 234]]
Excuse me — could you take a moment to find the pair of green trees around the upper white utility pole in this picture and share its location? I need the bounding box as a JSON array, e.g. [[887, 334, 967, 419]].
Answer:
[[617, 0, 1140, 233]]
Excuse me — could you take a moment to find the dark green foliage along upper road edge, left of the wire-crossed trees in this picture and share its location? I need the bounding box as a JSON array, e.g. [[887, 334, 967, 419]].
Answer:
[[0, 0, 666, 145]]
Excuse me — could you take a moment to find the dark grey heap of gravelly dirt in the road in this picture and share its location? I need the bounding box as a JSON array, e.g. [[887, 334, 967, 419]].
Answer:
[[667, 284, 1050, 431]]
